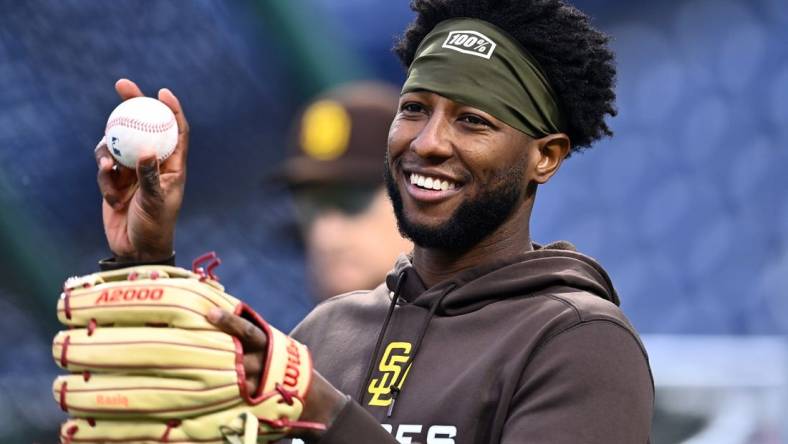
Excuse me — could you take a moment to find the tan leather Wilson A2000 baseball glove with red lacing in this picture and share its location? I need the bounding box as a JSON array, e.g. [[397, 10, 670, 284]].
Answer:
[[52, 255, 324, 444]]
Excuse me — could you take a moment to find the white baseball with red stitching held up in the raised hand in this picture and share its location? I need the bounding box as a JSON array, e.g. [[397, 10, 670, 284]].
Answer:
[[104, 97, 178, 169]]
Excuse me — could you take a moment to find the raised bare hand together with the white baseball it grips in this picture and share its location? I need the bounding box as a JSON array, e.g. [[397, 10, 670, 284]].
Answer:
[[95, 79, 189, 261]]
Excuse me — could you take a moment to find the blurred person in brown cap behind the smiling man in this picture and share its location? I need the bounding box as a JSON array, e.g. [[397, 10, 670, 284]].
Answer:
[[278, 81, 412, 300]]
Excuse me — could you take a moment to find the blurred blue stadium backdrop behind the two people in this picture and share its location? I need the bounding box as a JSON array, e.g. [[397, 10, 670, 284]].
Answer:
[[0, 0, 788, 444]]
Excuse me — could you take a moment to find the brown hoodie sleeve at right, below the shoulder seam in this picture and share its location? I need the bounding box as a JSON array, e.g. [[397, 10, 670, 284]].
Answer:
[[501, 320, 654, 444]]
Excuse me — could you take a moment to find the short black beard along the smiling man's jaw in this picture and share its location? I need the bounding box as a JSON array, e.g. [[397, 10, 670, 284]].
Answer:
[[384, 156, 525, 251]]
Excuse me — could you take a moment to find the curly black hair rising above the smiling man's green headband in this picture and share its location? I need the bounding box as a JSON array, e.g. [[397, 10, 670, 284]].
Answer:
[[394, 0, 616, 152]]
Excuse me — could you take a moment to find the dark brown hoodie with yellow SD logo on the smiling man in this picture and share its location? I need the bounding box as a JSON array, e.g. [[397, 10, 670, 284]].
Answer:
[[293, 242, 654, 444]]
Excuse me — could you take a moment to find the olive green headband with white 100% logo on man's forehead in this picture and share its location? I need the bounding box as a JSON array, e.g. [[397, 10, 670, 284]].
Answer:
[[402, 18, 566, 138]]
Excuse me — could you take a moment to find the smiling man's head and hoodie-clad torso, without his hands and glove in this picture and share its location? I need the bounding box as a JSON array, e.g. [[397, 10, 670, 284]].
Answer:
[[293, 0, 653, 444]]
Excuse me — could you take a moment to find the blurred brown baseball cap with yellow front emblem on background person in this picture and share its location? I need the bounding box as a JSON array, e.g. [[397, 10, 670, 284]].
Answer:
[[275, 81, 399, 187]]
